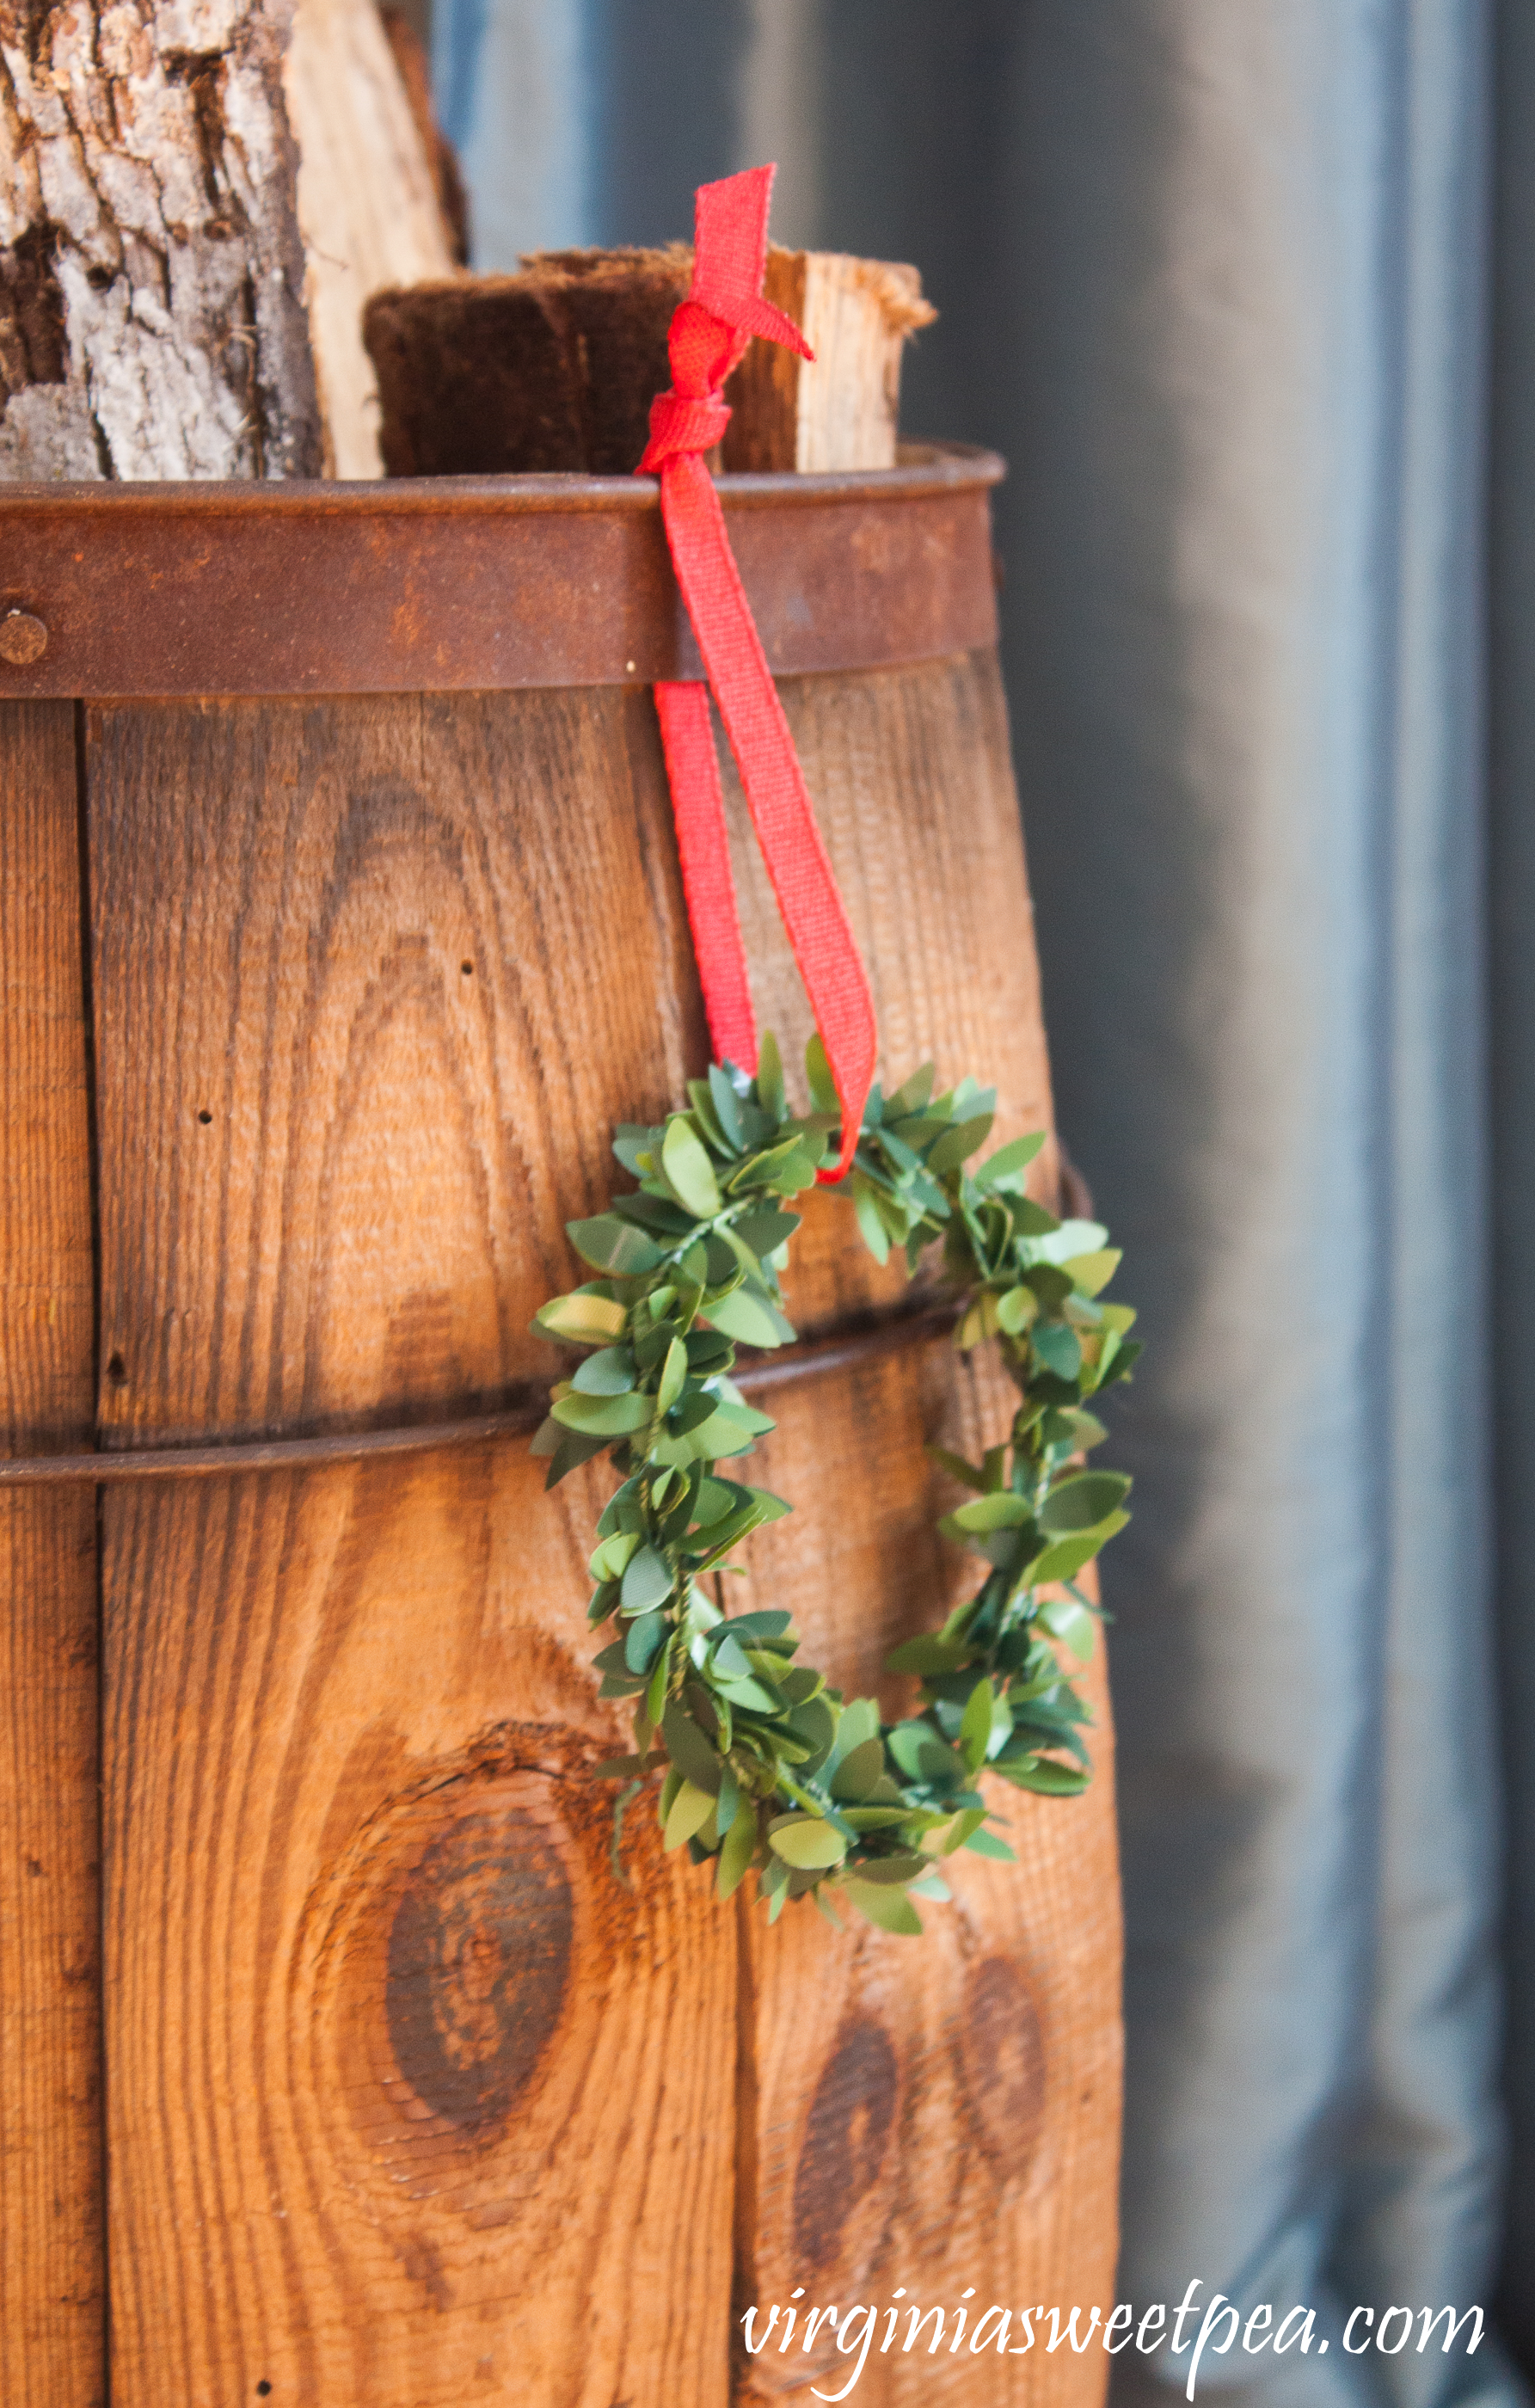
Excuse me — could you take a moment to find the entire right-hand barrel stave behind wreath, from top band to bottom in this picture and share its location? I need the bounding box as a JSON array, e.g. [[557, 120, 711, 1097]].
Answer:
[[732, 655, 1119, 2408]]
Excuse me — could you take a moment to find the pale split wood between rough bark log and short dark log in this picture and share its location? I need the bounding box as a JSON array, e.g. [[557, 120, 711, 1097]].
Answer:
[[284, 0, 464, 476]]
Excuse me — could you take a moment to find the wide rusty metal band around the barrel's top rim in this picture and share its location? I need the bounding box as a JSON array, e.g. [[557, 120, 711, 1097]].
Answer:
[[0, 445, 1001, 701]]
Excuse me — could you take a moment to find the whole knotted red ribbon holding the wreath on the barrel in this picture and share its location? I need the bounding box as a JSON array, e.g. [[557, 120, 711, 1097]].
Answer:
[[635, 166, 875, 1180]]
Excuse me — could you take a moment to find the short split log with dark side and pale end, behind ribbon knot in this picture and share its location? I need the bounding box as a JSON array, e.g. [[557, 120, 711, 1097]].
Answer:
[[363, 243, 934, 476]]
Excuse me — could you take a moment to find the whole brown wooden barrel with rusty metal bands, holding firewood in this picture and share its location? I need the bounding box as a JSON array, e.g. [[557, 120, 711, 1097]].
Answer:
[[0, 451, 1119, 2408]]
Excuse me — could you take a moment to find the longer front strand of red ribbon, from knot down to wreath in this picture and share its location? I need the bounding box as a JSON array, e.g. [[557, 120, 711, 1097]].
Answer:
[[661, 455, 878, 1182]]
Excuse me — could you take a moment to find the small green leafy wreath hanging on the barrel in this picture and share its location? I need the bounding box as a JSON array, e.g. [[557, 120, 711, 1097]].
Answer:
[[534, 1038, 1140, 1933]]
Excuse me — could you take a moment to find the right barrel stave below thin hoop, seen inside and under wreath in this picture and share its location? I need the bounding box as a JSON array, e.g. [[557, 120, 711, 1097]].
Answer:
[[736, 1351, 1119, 2408]]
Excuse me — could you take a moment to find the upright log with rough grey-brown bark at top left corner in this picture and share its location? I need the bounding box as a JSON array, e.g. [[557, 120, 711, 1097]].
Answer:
[[0, 0, 320, 476]]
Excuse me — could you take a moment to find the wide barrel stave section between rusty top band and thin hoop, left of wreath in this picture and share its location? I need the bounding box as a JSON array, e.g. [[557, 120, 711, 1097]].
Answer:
[[87, 686, 705, 1445]]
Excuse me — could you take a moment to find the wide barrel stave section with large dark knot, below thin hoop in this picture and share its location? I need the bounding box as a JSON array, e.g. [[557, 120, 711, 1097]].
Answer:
[[103, 1450, 736, 2408]]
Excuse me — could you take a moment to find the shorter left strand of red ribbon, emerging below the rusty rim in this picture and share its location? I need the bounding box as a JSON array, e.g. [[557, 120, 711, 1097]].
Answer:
[[654, 684, 758, 1072]]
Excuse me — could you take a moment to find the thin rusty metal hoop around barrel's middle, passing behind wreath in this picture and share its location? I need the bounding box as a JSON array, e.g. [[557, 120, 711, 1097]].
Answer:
[[0, 1305, 958, 1488]]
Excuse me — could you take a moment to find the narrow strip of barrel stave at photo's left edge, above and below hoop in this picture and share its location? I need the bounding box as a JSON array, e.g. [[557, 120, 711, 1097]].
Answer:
[[0, 703, 106, 2408]]
